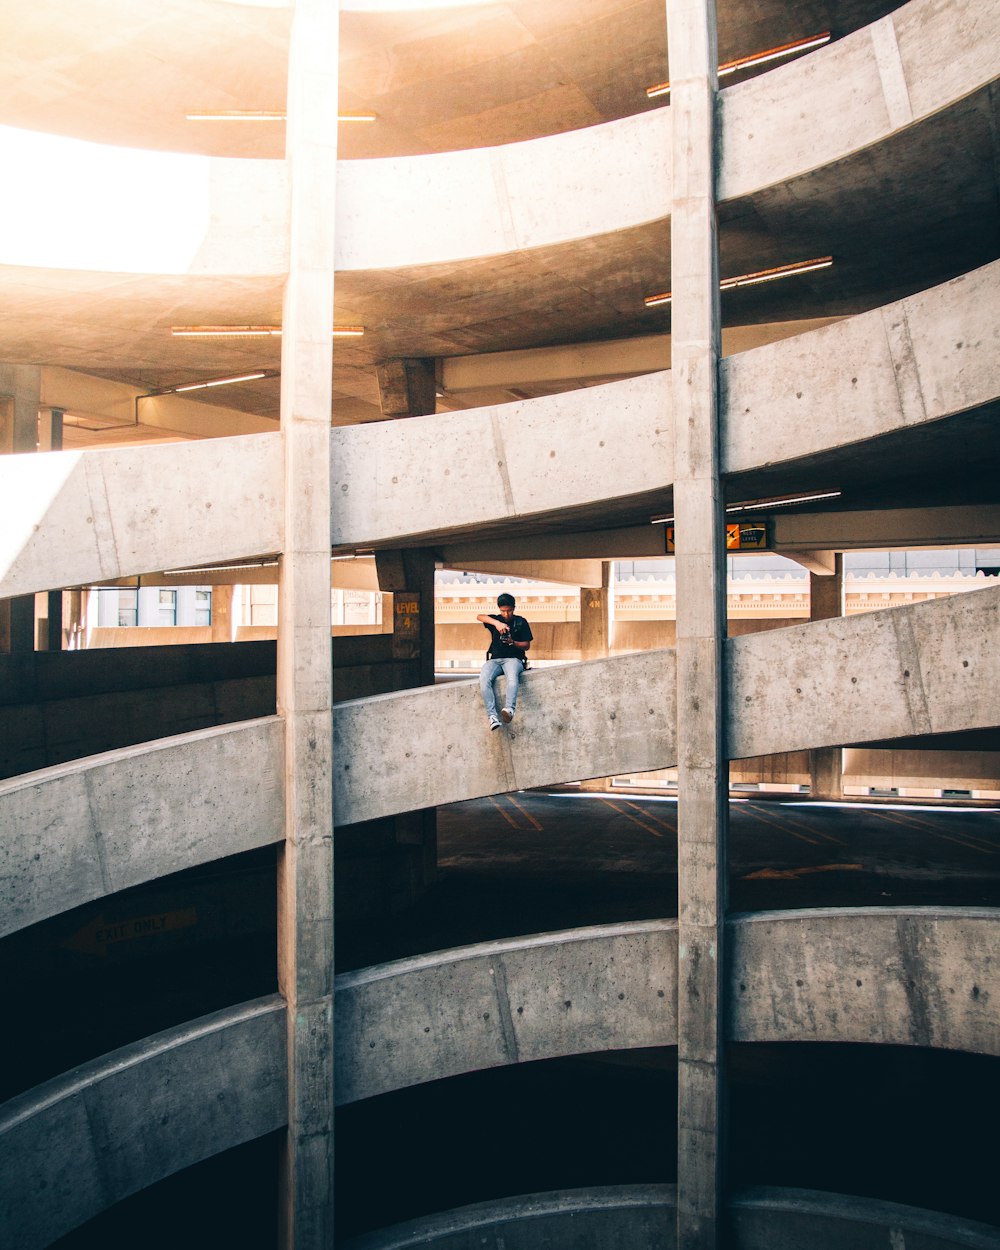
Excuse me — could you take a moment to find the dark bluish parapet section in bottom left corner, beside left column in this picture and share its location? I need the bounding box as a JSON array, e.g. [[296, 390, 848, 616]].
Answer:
[[0, 995, 286, 1250]]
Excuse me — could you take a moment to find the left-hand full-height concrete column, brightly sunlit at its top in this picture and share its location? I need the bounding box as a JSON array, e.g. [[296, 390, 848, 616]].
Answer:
[[278, 0, 340, 1250]]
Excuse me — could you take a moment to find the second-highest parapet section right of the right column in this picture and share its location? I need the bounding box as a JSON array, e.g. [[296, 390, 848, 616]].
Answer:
[[721, 261, 1000, 474]]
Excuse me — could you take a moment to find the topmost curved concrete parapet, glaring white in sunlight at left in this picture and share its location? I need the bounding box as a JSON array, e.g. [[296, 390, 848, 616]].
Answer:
[[0, 0, 1000, 281]]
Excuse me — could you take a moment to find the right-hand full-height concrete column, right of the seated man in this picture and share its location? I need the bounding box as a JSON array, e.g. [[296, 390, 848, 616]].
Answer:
[[666, 0, 729, 1250]]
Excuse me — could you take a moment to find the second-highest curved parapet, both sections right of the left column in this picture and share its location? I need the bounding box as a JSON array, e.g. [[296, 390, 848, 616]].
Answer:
[[331, 263, 1000, 546]]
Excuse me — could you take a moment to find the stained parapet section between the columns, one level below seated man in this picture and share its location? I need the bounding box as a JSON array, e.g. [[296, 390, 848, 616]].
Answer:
[[335, 920, 678, 1104]]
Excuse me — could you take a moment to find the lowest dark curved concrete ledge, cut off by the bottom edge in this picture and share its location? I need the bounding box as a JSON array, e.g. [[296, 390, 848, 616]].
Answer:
[[344, 1185, 1000, 1250]]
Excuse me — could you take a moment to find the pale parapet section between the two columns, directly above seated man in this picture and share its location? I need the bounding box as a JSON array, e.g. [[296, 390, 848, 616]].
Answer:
[[330, 373, 674, 546]]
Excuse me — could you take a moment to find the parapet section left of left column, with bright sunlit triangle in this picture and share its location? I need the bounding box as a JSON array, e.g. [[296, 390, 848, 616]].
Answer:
[[0, 434, 283, 599]]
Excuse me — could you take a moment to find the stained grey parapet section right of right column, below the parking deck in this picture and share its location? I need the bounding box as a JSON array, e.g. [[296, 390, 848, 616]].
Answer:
[[728, 908, 1000, 1055]]
